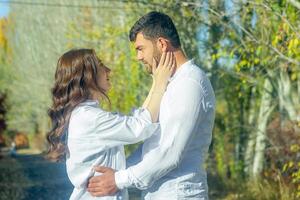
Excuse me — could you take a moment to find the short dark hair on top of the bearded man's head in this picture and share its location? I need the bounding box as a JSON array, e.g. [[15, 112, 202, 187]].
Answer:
[[129, 11, 180, 48]]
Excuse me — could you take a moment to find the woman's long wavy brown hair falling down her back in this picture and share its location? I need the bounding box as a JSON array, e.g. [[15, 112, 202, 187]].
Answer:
[[47, 49, 109, 161]]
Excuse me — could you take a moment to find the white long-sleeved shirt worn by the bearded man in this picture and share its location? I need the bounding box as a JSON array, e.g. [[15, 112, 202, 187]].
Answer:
[[115, 60, 215, 200]]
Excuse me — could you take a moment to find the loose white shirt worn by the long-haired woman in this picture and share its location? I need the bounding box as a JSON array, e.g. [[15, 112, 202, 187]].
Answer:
[[66, 100, 159, 200]]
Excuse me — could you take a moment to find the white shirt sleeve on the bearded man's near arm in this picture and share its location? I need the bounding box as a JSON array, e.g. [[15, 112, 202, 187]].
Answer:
[[115, 80, 211, 189]]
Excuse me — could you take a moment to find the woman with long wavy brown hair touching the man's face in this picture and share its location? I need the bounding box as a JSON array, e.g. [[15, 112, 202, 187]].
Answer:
[[47, 49, 175, 199]]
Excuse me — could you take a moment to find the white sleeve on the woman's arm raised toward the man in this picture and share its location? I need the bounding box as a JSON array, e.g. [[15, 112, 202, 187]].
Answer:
[[68, 108, 159, 148]]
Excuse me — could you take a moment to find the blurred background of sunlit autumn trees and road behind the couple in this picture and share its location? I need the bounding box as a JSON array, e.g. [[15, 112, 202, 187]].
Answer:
[[0, 0, 300, 200]]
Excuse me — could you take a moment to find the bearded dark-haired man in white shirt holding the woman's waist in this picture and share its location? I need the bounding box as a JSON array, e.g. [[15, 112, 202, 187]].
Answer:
[[88, 12, 215, 200]]
